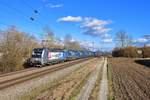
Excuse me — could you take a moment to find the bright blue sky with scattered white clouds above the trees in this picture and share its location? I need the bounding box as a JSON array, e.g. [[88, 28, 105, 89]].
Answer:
[[0, 0, 150, 50]]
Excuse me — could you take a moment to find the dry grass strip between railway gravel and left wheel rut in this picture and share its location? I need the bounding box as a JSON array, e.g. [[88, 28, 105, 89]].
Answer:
[[36, 59, 97, 100]]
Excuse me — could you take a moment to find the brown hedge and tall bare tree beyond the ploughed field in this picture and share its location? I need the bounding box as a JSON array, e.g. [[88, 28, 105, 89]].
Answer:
[[112, 31, 150, 58]]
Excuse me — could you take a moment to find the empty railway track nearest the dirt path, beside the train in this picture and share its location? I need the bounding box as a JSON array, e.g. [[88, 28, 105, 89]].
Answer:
[[0, 58, 90, 90]]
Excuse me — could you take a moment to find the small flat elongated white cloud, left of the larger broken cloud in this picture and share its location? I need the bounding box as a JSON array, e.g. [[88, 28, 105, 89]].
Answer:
[[57, 16, 82, 22]]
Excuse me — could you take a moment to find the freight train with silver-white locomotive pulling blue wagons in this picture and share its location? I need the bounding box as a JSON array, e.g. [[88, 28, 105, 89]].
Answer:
[[29, 48, 95, 66]]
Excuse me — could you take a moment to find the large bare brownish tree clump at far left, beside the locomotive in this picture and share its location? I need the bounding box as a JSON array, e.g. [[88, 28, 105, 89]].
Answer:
[[0, 27, 38, 72]]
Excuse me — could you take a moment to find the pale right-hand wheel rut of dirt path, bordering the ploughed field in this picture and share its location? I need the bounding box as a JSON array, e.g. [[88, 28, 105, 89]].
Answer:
[[98, 58, 108, 100]]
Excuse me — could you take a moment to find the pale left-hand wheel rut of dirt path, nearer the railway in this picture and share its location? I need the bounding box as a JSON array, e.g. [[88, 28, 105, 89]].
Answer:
[[77, 59, 104, 100]]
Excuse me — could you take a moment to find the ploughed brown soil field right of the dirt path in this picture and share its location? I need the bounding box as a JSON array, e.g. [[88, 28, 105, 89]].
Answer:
[[109, 58, 150, 100]]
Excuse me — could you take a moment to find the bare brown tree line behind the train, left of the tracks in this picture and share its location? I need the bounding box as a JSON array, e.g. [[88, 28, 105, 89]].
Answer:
[[0, 26, 82, 73]]
